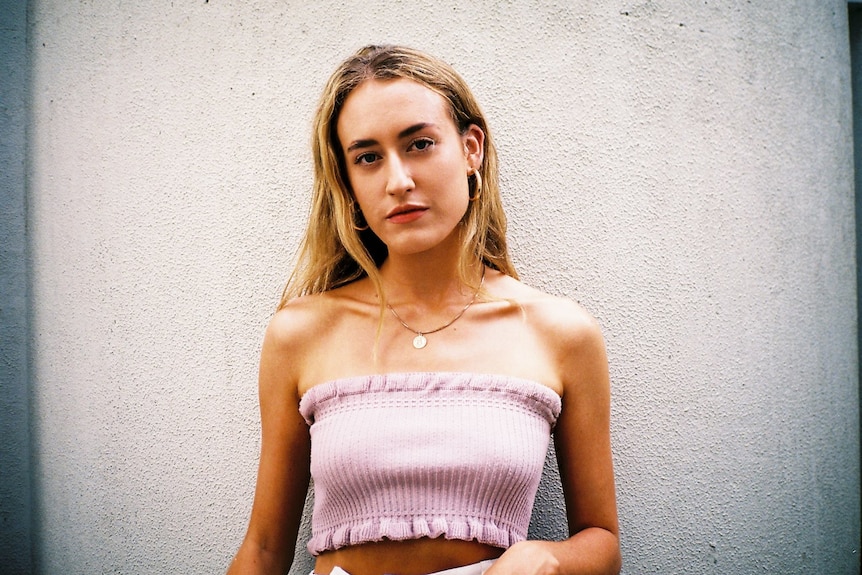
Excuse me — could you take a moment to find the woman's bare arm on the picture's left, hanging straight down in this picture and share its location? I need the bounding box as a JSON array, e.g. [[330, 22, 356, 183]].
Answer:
[[228, 308, 310, 575]]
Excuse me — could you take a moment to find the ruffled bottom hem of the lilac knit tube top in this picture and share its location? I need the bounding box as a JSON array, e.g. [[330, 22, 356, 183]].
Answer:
[[307, 517, 526, 555]]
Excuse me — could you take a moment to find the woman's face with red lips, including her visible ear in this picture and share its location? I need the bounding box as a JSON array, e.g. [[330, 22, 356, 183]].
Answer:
[[336, 79, 485, 255]]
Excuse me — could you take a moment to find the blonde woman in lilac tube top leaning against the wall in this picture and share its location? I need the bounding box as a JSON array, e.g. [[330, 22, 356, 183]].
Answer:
[[229, 46, 620, 575]]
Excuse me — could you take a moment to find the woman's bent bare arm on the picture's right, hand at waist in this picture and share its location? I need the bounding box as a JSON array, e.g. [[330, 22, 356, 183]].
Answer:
[[486, 304, 622, 575]]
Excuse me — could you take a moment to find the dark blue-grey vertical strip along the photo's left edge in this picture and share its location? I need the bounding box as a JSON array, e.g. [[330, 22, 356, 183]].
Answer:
[[0, 0, 33, 575]]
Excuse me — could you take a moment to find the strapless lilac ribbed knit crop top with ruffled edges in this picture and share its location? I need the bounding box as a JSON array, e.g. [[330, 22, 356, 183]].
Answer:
[[299, 373, 561, 555]]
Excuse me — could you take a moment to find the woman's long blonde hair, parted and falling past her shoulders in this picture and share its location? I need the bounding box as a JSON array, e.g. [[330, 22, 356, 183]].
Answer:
[[279, 46, 518, 309]]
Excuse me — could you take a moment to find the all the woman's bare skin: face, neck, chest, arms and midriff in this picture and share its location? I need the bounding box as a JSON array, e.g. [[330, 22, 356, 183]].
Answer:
[[228, 79, 620, 575]]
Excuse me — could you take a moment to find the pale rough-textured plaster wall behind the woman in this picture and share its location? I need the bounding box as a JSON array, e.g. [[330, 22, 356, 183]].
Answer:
[[23, 0, 860, 574]]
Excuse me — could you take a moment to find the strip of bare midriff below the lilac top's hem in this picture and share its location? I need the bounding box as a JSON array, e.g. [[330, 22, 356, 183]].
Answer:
[[314, 538, 504, 575]]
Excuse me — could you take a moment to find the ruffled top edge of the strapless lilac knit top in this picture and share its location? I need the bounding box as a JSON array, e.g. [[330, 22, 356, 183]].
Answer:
[[299, 372, 562, 426]]
